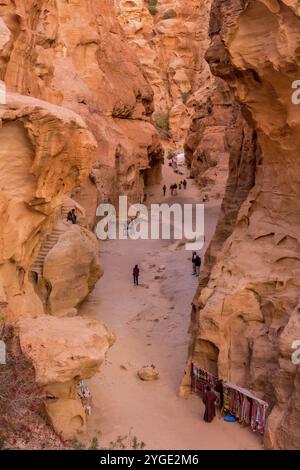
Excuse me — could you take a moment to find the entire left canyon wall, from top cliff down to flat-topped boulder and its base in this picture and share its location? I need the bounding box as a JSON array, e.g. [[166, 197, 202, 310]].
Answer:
[[0, 0, 163, 438]]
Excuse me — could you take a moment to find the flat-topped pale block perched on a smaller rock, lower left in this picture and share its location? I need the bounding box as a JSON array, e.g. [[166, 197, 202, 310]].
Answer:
[[18, 315, 114, 386]]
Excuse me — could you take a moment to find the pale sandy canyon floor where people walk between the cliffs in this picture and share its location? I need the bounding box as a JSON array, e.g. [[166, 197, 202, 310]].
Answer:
[[81, 166, 261, 450]]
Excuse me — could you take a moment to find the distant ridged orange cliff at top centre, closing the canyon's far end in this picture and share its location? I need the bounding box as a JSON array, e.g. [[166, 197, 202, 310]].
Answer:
[[115, 0, 211, 147]]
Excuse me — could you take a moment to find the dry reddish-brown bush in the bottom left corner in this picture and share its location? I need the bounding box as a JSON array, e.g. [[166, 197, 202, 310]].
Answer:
[[0, 327, 62, 449]]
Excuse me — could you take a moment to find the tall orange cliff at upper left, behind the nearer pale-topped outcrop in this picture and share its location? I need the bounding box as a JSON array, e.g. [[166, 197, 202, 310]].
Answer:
[[0, 0, 162, 223]]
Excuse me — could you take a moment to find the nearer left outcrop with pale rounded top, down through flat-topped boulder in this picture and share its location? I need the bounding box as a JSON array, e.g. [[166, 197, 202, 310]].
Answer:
[[0, 93, 112, 438]]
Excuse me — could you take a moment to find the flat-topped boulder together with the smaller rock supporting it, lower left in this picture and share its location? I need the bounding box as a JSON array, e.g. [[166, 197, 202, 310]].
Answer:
[[18, 315, 114, 439]]
